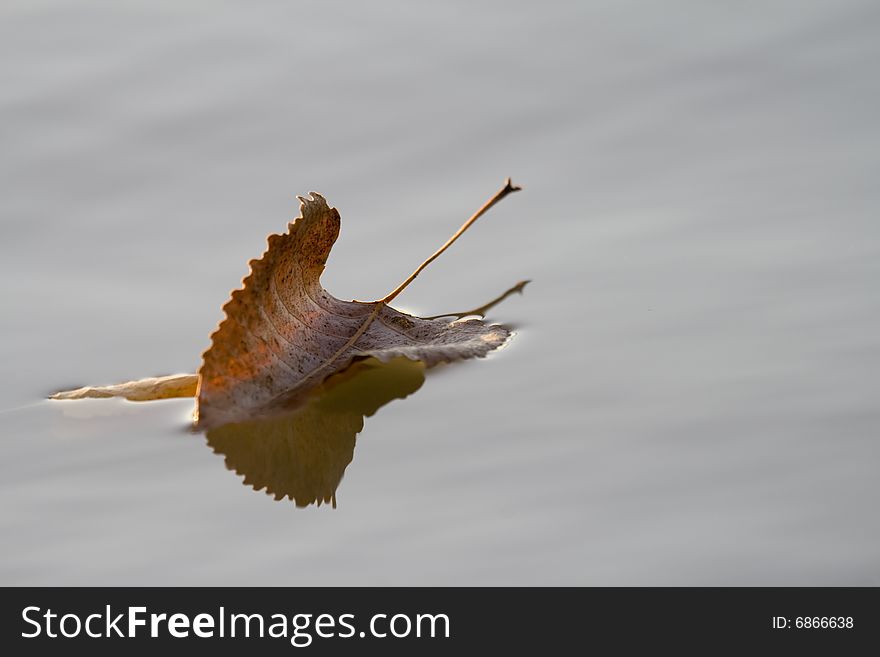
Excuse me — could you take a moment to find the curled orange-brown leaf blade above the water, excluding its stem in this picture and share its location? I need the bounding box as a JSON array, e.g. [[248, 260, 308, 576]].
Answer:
[[197, 192, 510, 428]]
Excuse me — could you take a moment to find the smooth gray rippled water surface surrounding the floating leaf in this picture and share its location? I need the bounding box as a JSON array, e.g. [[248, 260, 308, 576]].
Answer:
[[0, 1, 880, 585]]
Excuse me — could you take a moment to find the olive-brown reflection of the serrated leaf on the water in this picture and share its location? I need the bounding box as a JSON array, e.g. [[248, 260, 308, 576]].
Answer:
[[207, 358, 425, 507]]
